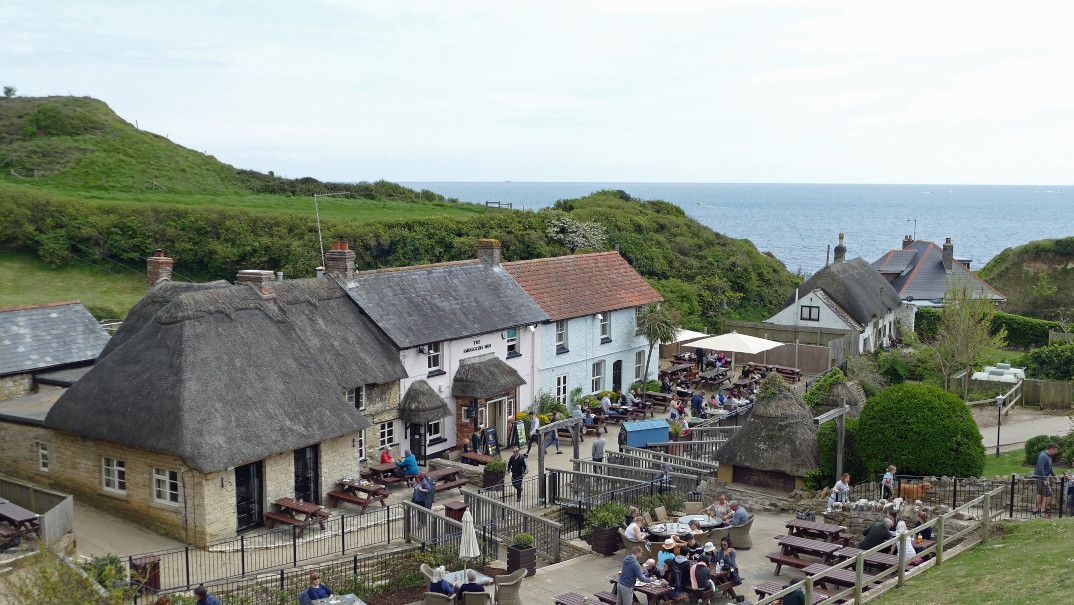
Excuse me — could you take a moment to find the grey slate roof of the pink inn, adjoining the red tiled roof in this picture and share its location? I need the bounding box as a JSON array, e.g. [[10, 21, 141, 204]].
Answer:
[[347, 259, 548, 348]]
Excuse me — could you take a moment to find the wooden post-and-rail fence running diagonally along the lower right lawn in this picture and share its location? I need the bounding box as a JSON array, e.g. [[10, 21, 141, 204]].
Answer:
[[757, 487, 1004, 605]]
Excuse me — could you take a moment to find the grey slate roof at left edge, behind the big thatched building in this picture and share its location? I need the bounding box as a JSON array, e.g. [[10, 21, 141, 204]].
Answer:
[[0, 301, 108, 376]]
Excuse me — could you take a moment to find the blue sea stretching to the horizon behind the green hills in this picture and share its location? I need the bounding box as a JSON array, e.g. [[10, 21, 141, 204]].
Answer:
[[403, 182, 1074, 274]]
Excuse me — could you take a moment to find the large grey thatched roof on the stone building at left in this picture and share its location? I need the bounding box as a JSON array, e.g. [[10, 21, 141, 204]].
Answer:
[[45, 278, 406, 473]]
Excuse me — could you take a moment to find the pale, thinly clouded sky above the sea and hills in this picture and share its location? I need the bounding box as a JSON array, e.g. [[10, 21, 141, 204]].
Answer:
[[8, 0, 1074, 185]]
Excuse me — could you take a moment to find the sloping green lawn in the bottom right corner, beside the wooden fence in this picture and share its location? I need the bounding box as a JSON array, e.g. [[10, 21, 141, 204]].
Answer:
[[871, 519, 1074, 605]]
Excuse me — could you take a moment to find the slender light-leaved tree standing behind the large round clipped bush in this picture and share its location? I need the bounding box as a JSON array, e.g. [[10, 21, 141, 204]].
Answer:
[[923, 276, 1006, 397]]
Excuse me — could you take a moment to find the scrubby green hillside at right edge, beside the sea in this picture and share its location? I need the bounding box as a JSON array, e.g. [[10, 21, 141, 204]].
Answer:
[[977, 237, 1074, 321]]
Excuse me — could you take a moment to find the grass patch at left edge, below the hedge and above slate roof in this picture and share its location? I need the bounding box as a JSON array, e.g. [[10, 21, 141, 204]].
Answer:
[[0, 253, 146, 319]]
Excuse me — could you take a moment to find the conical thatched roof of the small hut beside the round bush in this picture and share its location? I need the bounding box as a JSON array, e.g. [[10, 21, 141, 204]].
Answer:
[[715, 390, 821, 477]]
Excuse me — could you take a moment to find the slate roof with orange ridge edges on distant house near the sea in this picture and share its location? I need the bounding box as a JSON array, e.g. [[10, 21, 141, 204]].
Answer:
[[872, 240, 1006, 302]]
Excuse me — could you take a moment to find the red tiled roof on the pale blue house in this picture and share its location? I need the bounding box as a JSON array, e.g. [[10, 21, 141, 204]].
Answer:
[[504, 253, 664, 321]]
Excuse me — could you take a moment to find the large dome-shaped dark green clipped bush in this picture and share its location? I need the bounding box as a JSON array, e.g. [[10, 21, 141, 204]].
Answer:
[[856, 385, 985, 477]]
